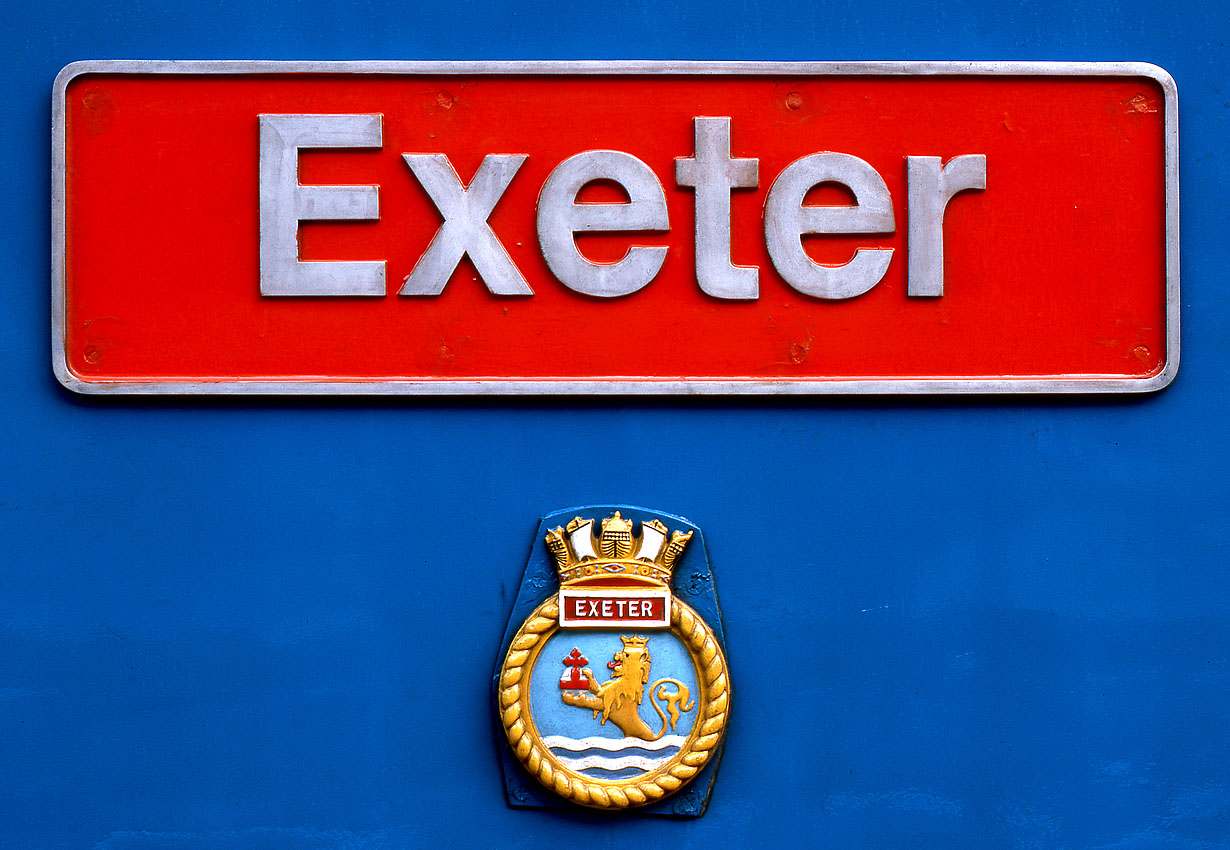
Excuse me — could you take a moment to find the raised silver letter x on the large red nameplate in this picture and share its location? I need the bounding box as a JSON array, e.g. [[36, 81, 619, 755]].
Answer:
[[399, 154, 534, 295]]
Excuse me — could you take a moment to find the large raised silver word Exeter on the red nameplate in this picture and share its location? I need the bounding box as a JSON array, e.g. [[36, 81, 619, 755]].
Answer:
[[260, 114, 986, 300]]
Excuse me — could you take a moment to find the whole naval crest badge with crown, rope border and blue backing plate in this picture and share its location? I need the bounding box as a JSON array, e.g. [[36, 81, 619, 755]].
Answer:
[[494, 506, 731, 816]]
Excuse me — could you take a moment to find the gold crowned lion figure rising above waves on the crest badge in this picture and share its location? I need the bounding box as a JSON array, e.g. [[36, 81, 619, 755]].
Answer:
[[561, 636, 695, 741]]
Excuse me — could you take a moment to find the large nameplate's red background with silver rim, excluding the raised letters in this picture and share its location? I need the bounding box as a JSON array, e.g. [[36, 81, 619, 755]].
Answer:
[[53, 63, 1178, 392]]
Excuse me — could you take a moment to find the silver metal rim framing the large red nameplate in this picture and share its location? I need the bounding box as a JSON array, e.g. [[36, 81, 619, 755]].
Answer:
[[52, 59, 1180, 395]]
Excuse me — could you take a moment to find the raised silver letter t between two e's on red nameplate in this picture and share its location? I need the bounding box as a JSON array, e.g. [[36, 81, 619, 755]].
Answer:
[[675, 118, 760, 299]]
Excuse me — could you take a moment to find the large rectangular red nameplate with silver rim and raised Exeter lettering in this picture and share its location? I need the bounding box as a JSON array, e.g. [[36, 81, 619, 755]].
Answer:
[[52, 62, 1178, 398]]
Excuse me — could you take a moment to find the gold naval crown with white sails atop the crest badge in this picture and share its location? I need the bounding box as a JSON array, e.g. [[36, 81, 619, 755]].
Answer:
[[546, 510, 692, 587]]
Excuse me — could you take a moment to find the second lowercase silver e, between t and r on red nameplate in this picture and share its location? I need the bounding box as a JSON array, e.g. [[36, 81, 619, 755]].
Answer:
[[765, 154, 894, 299]]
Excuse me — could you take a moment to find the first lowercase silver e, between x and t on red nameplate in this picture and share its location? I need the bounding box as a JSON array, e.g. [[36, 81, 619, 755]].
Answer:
[[538, 150, 670, 298]]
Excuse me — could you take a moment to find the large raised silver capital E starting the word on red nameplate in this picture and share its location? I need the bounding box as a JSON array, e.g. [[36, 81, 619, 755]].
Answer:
[[261, 114, 385, 295]]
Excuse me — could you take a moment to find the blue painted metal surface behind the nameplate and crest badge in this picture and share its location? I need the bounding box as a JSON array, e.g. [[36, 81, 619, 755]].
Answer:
[[0, 0, 1230, 850]]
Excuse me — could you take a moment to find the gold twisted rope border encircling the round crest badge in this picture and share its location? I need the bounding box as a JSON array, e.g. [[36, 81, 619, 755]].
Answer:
[[499, 594, 731, 809]]
